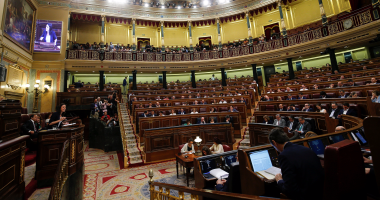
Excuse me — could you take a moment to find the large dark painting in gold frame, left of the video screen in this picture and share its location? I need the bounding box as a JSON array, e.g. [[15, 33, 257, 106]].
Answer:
[[4, 0, 34, 51]]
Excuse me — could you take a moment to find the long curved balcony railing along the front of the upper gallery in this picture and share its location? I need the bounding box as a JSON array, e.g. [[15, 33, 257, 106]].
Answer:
[[66, 6, 380, 62]]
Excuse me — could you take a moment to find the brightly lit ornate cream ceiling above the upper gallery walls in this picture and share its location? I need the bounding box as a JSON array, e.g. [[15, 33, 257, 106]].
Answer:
[[37, 0, 277, 21]]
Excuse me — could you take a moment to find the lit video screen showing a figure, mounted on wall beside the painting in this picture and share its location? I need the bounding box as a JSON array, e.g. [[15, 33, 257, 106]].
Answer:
[[34, 20, 62, 53]]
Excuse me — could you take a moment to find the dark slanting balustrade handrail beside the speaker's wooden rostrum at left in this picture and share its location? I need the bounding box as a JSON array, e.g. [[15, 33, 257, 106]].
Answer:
[[49, 140, 70, 200]]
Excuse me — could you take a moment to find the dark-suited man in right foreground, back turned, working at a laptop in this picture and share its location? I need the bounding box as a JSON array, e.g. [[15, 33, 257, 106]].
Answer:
[[269, 128, 324, 200]]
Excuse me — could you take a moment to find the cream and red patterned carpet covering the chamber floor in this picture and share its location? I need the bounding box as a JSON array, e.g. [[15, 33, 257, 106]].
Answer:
[[25, 143, 195, 200]]
